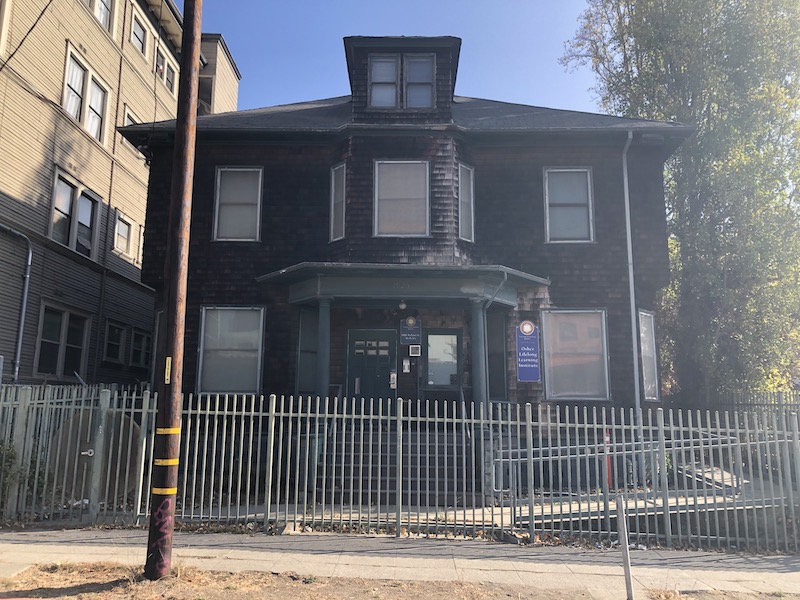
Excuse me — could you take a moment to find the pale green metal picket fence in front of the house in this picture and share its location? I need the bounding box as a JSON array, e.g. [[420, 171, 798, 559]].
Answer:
[[0, 387, 800, 552]]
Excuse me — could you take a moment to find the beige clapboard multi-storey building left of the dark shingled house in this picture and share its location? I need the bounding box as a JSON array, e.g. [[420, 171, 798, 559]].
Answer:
[[0, 0, 240, 383]]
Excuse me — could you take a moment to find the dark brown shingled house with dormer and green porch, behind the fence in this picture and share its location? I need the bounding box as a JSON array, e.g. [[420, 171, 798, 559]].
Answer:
[[123, 37, 691, 406]]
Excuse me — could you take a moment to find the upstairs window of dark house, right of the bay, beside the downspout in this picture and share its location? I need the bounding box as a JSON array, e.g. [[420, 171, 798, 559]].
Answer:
[[544, 168, 594, 242]]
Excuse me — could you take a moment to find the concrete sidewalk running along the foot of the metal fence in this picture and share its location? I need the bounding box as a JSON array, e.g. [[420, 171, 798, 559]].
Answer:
[[0, 529, 800, 600]]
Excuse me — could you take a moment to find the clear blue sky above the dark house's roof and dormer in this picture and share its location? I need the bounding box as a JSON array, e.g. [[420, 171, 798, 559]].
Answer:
[[177, 0, 597, 112]]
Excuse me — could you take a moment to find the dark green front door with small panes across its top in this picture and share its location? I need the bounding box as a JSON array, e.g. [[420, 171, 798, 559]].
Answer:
[[347, 329, 397, 400]]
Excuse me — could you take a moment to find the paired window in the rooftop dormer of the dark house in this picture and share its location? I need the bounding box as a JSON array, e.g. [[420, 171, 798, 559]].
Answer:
[[369, 54, 435, 109]]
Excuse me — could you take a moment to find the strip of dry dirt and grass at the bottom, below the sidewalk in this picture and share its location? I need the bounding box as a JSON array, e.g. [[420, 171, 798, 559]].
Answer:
[[0, 563, 800, 600]]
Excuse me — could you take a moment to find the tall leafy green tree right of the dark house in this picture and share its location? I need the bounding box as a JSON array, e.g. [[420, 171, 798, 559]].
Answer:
[[562, 0, 800, 400]]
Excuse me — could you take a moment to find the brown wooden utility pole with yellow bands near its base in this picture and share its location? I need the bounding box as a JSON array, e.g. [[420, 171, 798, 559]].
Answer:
[[144, 0, 203, 580]]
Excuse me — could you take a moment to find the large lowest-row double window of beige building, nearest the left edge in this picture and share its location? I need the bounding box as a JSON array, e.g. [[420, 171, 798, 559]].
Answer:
[[36, 305, 89, 378]]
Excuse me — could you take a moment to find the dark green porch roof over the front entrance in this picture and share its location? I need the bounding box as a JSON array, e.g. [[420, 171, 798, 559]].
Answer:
[[256, 262, 550, 306]]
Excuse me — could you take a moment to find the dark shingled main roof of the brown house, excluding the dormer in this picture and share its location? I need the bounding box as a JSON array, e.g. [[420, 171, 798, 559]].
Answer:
[[120, 96, 693, 140]]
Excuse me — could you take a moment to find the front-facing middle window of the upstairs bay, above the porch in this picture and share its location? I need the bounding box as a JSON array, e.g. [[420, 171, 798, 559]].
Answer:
[[374, 160, 429, 237]]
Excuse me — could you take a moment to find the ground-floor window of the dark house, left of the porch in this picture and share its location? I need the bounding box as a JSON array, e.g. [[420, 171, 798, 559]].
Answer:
[[198, 306, 264, 393]]
